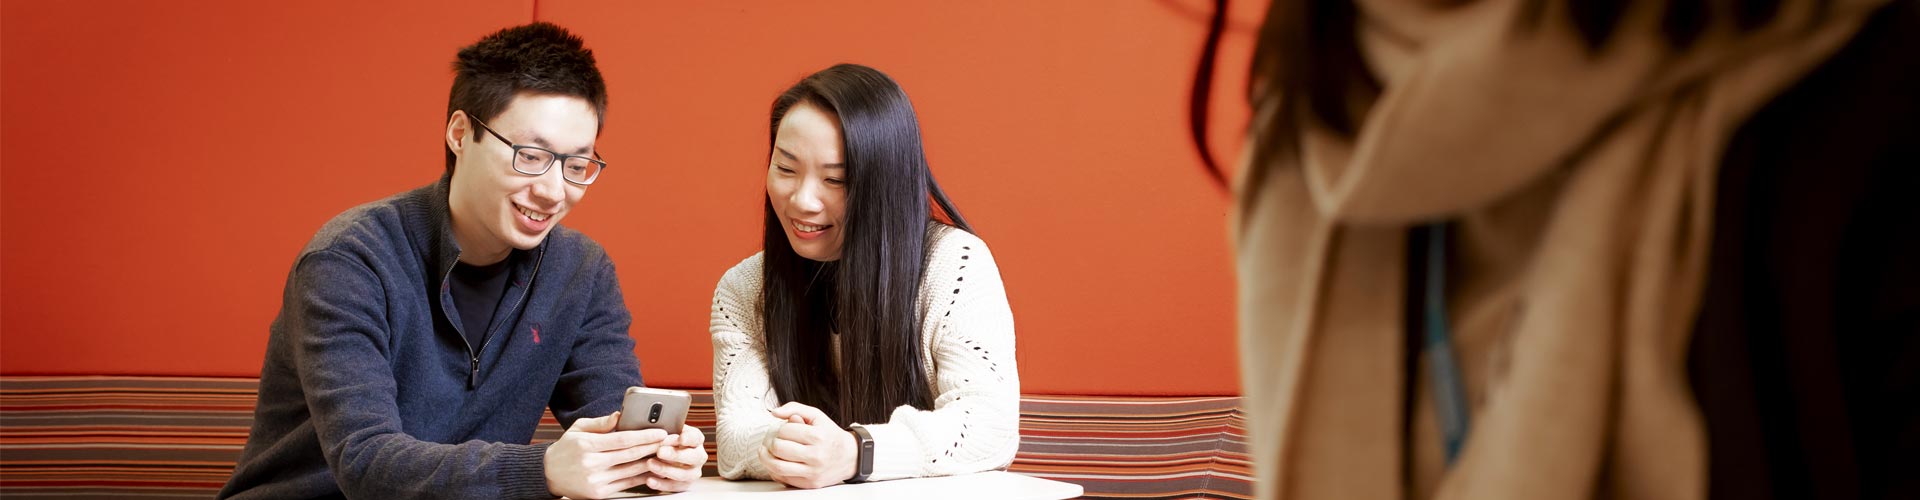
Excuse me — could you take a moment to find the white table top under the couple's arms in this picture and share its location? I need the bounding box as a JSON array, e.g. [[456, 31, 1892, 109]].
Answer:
[[629, 471, 1083, 500]]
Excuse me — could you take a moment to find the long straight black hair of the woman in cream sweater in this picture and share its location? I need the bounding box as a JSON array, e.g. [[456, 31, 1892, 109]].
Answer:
[[760, 63, 973, 427]]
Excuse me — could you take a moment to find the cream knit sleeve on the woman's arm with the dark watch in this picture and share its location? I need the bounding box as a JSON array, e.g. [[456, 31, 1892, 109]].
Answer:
[[864, 229, 1020, 481]]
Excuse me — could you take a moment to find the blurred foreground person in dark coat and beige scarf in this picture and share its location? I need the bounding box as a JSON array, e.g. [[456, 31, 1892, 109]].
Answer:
[[1205, 0, 1920, 500]]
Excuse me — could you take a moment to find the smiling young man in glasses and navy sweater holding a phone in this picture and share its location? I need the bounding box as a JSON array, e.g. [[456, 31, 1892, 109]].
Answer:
[[221, 23, 707, 498]]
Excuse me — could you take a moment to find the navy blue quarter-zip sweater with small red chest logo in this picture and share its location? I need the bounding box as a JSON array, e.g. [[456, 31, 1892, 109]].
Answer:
[[219, 177, 641, 498]]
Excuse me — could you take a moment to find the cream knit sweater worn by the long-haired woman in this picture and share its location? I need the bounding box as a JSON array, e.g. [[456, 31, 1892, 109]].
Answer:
[[708, 225, 1020, 481]]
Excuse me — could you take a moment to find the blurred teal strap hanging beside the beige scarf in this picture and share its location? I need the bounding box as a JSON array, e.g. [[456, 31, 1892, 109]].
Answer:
[[1423, 223, 1469, 465]]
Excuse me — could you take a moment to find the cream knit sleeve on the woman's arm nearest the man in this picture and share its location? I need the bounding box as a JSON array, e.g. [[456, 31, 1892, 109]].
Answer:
[[707, 254, 781, 479]]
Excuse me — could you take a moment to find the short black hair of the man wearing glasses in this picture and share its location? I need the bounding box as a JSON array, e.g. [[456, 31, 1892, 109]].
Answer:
[[442, 23, 607, 175]]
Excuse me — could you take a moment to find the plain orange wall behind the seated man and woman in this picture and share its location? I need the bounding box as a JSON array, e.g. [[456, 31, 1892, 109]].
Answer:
[[0, 0, 1260, 394]]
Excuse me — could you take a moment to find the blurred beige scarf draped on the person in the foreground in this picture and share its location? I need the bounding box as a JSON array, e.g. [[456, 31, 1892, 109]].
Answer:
[[1233, 0, 1880, 500]]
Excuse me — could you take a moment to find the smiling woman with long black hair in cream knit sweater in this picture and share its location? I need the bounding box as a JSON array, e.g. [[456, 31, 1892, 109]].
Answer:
[[710, 63, 1020, 488]]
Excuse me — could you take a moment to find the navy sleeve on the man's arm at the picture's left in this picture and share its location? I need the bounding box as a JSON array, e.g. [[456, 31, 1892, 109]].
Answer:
[[291, 250, 551, 498]]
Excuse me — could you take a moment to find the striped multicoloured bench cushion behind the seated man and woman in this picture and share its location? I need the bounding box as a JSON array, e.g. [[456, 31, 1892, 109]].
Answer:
[[0, 377, 1252, 498]]
